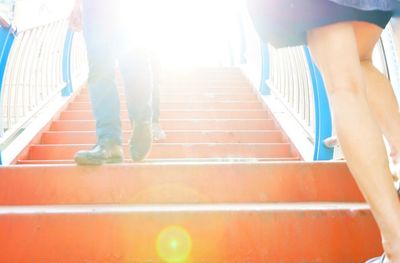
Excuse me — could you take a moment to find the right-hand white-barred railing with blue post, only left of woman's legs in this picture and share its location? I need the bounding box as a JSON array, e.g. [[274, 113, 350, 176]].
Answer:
[[243, 5, 333, 160]]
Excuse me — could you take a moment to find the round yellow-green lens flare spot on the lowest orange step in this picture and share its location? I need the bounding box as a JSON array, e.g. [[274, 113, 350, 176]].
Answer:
[[156, 226, 192, 263]]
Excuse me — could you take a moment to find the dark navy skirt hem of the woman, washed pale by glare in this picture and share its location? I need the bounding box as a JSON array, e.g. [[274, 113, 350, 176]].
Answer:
[[247, 0, 393, 48]]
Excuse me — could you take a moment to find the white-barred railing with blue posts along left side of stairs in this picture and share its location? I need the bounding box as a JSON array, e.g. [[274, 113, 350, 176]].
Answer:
[[0, 0, 87, 164]]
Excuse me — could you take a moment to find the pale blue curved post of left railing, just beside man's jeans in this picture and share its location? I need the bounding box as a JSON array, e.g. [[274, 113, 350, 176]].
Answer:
[[62, 30, 74, 97]]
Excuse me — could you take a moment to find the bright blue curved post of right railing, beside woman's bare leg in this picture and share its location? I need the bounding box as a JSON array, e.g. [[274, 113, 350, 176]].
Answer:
[[304, 47, 333, 161]]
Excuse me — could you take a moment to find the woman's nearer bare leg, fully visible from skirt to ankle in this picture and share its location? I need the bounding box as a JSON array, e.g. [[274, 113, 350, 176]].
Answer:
[[308, 22, 400, 263]]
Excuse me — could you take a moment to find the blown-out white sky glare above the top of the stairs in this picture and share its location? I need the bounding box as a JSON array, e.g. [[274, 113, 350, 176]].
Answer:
[[121, 0, 244, 67]]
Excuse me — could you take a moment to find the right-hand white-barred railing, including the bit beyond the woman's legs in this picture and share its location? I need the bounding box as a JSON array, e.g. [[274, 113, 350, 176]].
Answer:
[[244, 7, 400, 160]]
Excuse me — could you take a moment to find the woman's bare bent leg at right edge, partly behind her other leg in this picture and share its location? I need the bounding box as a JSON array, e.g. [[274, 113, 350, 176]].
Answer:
[[353, 22, 400, 176]]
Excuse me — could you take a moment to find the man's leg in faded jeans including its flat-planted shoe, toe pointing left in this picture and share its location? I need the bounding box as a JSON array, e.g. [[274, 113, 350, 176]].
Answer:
[[75, 1, 123, 164]]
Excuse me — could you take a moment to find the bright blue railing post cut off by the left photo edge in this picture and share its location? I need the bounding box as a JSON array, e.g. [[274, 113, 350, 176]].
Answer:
[[0, 27, 14, 165]]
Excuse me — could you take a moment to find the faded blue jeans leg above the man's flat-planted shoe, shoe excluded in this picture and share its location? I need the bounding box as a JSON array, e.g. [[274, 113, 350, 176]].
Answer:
[[83, 1, 121, 143]]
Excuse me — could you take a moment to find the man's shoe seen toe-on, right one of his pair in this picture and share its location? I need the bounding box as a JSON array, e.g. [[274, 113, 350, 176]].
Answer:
[[129, 122, 153, 162]]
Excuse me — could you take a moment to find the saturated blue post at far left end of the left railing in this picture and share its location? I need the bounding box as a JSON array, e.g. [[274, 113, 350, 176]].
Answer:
[[0, 26, 14, 165]]
